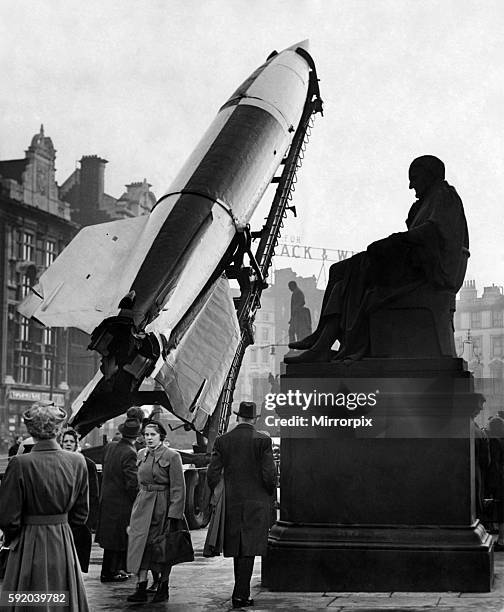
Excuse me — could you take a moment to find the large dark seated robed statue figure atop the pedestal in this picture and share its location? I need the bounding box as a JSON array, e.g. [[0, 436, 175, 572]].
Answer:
[[285, 155, 469, 363]]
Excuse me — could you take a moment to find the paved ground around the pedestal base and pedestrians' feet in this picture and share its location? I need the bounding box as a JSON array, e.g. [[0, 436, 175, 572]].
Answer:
[[78, 530, 504, 612]]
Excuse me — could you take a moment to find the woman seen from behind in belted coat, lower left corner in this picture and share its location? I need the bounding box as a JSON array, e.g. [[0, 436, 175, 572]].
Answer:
[[0, 402, 89, 612]]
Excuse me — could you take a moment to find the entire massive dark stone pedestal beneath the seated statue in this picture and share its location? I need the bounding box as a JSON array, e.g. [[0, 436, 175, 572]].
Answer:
[[262, 358, 493, 592]]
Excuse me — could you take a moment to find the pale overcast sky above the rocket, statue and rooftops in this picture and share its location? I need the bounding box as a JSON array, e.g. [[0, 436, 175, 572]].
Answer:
[[0, 0, 504, 288]]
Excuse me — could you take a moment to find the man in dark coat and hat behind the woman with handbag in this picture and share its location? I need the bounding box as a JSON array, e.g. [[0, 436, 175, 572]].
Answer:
[[95, 418, 141, 582]]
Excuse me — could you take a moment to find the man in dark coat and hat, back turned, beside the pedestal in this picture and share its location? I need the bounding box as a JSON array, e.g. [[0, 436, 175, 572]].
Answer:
[[207, 402, 276, 608]]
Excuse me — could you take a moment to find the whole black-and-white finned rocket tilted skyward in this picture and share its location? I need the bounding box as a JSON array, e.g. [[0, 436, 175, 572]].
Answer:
[[19, 43, 313, 435]]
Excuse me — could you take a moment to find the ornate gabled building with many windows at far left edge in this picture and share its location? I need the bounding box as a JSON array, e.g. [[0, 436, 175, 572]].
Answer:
[[0, 126, 78, 444]]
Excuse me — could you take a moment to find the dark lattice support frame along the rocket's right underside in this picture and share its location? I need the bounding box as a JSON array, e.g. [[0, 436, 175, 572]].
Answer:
[[208, 49, 322, 444]]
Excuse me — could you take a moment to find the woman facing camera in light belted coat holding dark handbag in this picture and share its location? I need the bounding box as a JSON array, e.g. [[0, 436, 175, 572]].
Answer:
[[128, 421, 185, 602]]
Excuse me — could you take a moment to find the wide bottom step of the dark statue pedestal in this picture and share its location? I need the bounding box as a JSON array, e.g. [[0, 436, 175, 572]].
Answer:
[[261, 521, 493, 592]]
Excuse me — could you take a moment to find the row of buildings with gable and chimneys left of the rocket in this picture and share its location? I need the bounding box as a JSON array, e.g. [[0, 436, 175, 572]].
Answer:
[[0, 126, 156, 454]]
